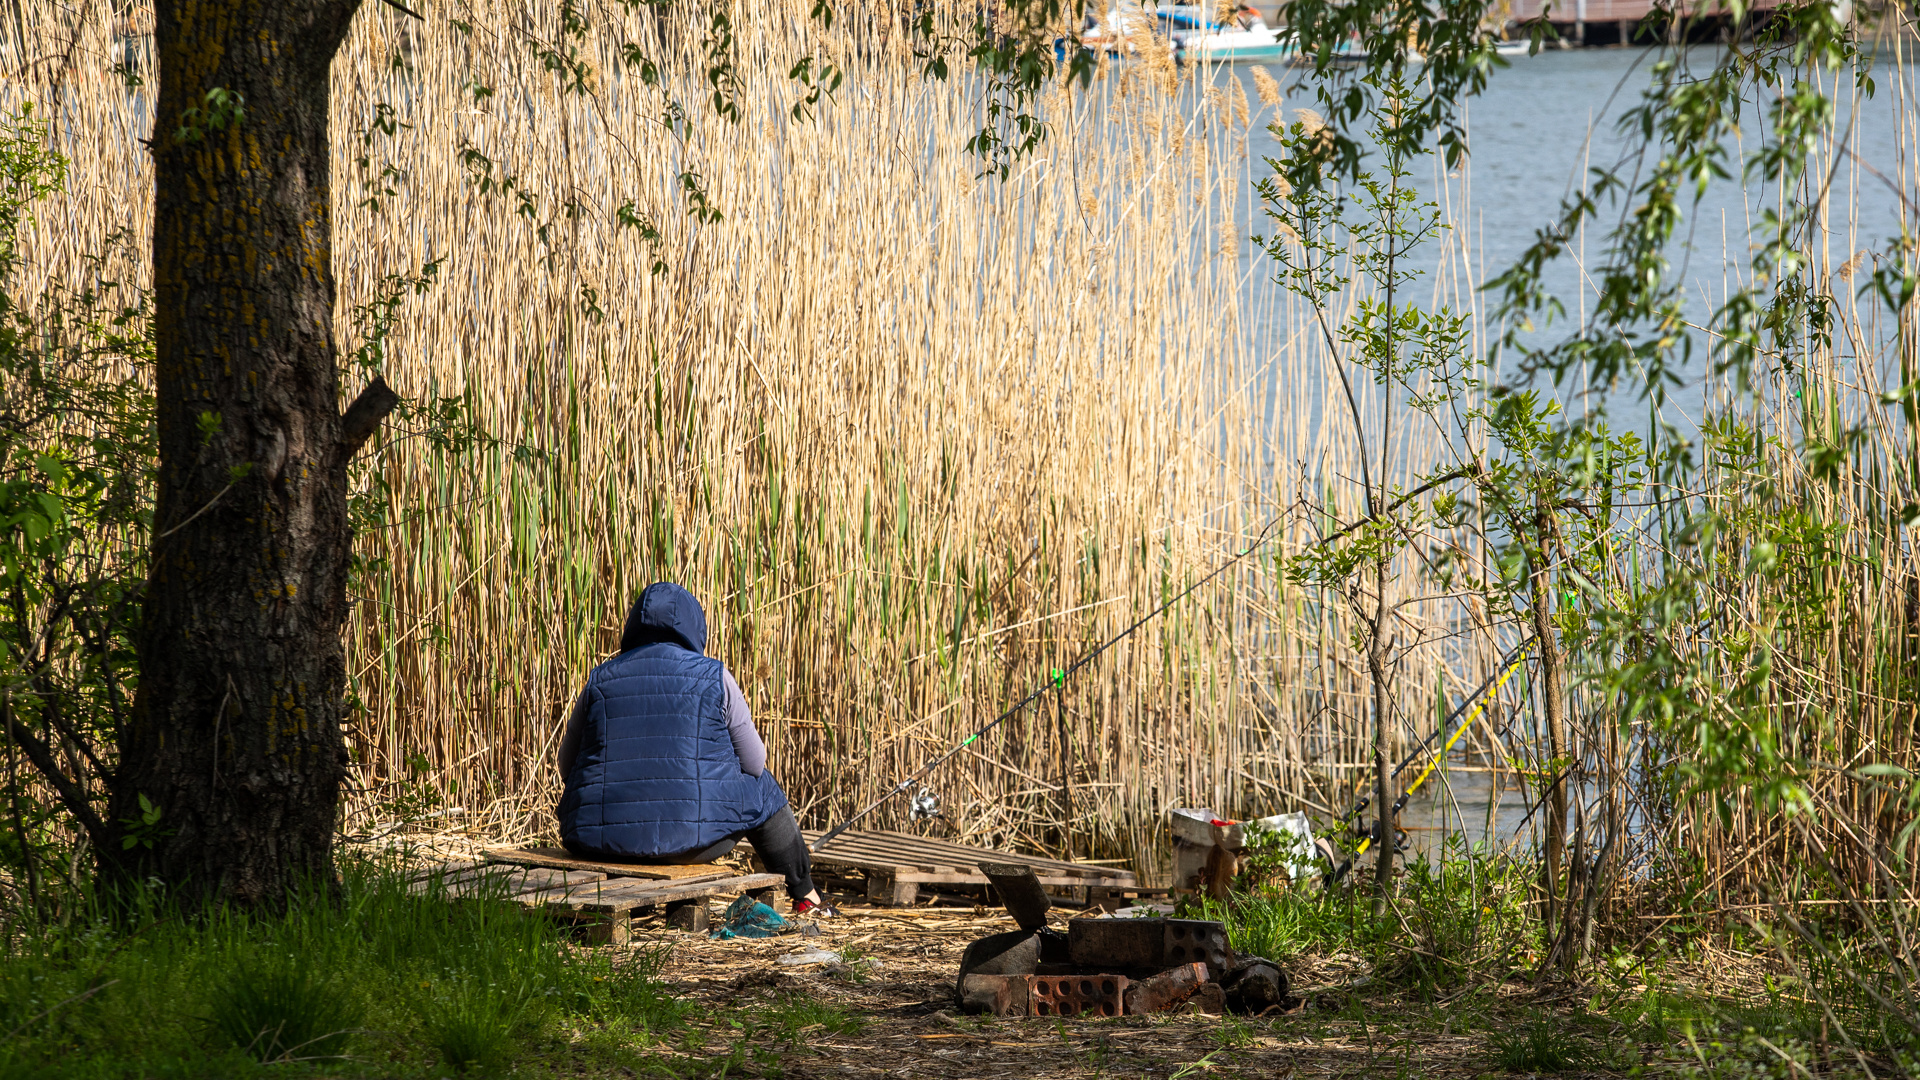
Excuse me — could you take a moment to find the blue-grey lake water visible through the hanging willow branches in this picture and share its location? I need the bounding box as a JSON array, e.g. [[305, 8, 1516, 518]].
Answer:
[[1212, 48, 1914, 430]]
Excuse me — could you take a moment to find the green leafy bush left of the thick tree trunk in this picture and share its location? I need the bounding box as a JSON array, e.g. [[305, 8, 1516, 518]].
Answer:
[[0, 104, 153, 920]]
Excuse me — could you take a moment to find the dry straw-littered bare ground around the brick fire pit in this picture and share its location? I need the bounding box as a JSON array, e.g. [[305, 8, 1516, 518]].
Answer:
[[583, 891, 1712, 1080]]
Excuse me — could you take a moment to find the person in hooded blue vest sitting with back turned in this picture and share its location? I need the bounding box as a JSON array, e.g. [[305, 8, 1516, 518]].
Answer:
[[559, 582, 837, 917]]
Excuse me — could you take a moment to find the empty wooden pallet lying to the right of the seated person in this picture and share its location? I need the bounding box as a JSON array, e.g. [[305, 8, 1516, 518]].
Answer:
[[801, 828, 1139, 907]]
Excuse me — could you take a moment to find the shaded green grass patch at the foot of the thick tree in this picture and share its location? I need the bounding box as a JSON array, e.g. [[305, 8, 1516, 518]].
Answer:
[[0, 865, 693, 1080]]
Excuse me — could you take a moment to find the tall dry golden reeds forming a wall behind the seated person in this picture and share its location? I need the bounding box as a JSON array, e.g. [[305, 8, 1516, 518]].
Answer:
[[8, 2, 1492, 876]]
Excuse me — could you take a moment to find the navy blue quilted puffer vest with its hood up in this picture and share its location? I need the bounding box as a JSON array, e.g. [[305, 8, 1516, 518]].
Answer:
[[559, 582, 787, 859]]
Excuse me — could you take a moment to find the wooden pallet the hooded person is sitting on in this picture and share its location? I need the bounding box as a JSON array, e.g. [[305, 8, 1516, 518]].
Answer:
[[415, 847, 783, 945]]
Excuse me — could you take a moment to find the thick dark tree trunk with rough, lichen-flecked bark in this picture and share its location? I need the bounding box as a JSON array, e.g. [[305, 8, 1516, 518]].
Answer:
[[100, 0, 394, 905]]
